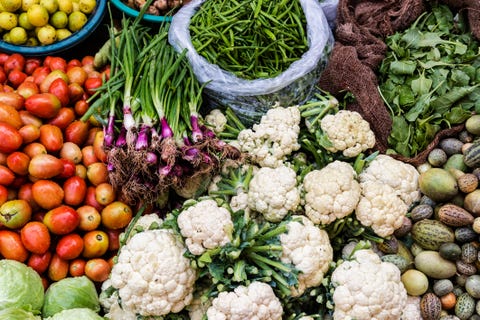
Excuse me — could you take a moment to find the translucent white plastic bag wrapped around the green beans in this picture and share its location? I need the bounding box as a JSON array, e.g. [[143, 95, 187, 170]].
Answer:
[[169, 0, 334, 123]]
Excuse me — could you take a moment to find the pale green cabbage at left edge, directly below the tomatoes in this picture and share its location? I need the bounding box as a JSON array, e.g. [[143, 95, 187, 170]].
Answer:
[[0, 259, 44, 314]]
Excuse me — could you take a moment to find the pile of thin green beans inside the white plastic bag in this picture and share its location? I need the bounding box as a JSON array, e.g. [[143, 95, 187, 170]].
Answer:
[[189, 0, 308, 80]]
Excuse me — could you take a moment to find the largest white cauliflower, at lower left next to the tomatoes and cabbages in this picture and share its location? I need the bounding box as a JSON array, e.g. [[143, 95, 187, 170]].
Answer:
[[110, 229, 196, 316]]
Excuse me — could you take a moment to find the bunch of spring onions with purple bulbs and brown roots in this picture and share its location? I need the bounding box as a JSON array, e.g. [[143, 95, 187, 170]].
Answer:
[[84, 19, 240, 208]]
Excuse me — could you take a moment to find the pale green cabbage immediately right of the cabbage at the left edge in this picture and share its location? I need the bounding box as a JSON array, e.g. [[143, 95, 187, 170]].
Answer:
[[42, 276, 100, 318]]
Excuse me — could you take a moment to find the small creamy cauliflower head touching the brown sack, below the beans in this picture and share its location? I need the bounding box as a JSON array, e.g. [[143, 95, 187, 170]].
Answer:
[[320, 110, 375, 158]]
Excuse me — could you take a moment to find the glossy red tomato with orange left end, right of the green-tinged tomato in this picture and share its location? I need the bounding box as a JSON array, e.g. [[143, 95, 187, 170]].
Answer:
[[43, 205, 80, 235]]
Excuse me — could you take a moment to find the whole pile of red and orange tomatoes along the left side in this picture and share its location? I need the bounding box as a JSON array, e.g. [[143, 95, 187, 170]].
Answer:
[[0, 53, 133, 287]]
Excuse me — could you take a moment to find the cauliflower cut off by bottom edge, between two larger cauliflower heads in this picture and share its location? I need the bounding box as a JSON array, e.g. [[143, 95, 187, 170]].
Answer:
[[207, 281, 283, 320]]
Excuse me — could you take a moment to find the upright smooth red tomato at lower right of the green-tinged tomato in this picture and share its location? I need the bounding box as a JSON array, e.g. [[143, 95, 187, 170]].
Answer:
[[20, 221, 51, 254]]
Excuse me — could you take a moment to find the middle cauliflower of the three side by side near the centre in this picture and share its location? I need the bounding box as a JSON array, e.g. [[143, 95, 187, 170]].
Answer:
[[303, 160, 360, 225]]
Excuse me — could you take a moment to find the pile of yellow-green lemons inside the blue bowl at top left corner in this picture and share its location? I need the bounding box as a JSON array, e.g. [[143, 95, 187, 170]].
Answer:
[[0, 0, 97, 46]]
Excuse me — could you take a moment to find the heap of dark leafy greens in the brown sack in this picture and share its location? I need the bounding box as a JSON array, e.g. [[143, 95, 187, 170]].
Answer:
[[378, 3, 480, 157]]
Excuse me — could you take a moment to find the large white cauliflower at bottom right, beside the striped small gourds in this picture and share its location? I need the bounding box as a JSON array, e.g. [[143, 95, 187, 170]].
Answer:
[[331, 249, 407, 320]]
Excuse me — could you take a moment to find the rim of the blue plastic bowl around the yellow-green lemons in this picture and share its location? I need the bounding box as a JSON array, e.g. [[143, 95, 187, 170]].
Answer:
[[0, 0, 107, 56]]
